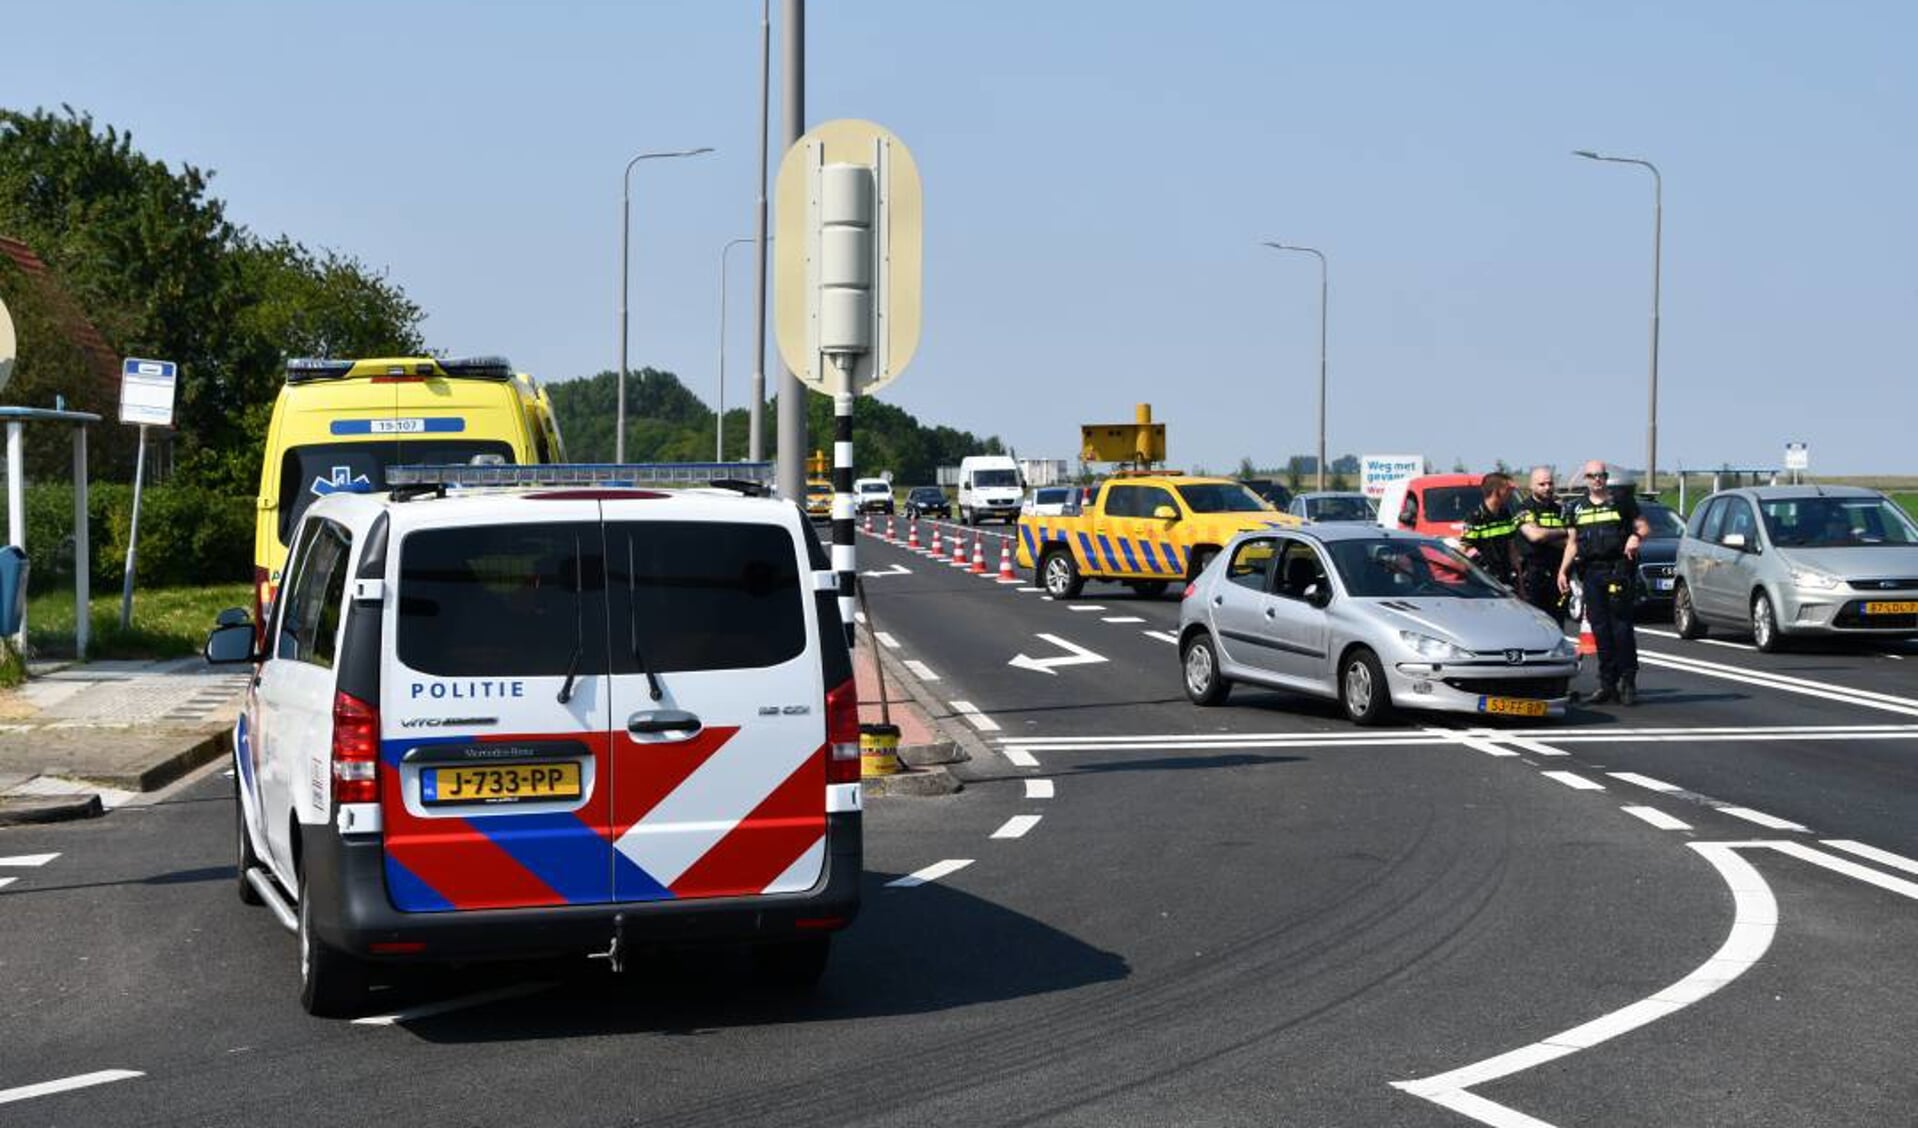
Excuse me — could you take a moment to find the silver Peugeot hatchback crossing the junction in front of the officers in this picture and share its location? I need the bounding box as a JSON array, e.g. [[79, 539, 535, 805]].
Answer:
[[1180, 524, 1579, 725]]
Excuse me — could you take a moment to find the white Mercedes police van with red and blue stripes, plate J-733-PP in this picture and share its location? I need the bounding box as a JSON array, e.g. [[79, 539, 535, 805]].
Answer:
[[207, 464, 861, 1015]]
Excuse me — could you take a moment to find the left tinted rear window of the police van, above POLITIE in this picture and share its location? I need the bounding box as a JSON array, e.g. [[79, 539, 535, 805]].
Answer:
[[399, 522, 606, 677]]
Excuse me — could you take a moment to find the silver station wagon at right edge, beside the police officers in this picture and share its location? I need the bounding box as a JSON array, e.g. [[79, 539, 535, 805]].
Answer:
[[1672, 485, 1918, 652]]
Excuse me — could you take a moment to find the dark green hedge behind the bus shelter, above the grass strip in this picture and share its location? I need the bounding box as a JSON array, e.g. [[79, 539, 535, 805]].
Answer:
[[0, 482, 255, 591]]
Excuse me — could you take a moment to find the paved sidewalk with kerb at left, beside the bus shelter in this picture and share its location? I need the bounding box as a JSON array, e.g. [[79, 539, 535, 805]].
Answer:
[[0, 658, 251, 827]]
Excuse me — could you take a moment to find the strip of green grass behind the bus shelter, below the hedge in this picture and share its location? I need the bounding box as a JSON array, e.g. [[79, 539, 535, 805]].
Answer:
[[27, 583, 253, 658]]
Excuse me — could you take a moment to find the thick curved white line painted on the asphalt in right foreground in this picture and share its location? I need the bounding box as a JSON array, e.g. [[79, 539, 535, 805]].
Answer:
[[1392, 842, 1772, 1128]]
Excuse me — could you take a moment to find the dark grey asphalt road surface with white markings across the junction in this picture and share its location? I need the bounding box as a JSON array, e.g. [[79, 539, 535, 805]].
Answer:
[[0, 517, 1918, 1126]]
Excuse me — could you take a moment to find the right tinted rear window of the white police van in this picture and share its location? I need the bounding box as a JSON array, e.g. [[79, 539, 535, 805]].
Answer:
[[606, 522, 806, 673]]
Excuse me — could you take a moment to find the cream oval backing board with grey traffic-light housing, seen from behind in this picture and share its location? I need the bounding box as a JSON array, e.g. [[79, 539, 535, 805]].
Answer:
[[773, 119, 924, 395]]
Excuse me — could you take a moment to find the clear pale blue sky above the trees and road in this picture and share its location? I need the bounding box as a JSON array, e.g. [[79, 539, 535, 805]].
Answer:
[[0, 0, 1918, 474]]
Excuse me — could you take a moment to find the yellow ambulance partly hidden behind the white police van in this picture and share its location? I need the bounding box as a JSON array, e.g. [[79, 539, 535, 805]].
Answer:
[[253, 357, 566, 623]]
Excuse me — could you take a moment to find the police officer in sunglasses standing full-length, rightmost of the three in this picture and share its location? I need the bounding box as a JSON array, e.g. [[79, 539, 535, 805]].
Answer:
[[1557, 462, 1646, 706]]
